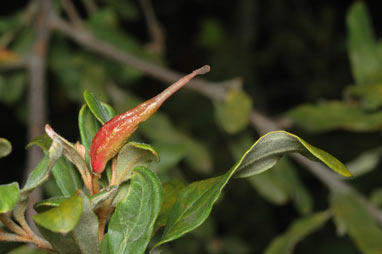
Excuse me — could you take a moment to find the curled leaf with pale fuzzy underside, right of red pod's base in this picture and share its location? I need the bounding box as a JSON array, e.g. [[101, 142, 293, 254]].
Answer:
[[113, 142, 159, 185]]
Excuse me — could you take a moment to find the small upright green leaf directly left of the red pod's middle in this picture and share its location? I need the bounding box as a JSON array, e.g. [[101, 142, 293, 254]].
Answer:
[[78, 105, 101, 151]]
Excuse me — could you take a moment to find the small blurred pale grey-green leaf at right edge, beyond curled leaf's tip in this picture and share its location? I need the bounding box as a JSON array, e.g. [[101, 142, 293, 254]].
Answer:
[[346, 148, 382, 177]]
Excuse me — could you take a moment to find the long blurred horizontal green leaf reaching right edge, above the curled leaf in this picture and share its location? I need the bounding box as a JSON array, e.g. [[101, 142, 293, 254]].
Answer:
[[287, 101, 382, 132]]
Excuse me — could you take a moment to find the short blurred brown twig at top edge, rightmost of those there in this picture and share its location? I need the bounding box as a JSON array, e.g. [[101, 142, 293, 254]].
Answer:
[[139, 0, 165, 54]]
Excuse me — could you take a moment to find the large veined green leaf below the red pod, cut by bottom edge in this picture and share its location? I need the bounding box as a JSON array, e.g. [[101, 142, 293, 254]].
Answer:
[[108, 167, 162, 254]]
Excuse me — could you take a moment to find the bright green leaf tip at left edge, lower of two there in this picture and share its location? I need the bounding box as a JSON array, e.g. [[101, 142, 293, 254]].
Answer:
[[0, 182, 20, 213]]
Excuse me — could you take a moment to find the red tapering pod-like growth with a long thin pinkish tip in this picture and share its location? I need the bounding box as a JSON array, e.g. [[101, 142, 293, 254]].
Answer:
[[90, 65, 210, 173]]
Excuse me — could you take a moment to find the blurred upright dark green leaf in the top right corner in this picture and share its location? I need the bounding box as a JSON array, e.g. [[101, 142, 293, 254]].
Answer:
[[347, 1, 382, 85]]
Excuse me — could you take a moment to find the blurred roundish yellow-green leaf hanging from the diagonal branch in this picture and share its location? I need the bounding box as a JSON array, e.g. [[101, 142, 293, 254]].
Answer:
[[215, 89, 252, 134]]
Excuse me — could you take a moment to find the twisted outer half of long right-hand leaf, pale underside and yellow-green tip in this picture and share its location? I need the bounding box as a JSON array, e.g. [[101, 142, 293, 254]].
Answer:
[[237, 131, 351, 177]]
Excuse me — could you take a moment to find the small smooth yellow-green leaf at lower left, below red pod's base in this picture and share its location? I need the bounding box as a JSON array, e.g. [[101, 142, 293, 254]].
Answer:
[[33, 194, 83, 234]]
